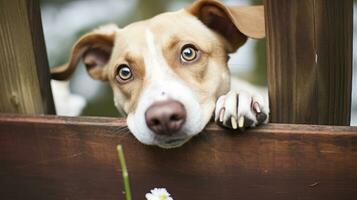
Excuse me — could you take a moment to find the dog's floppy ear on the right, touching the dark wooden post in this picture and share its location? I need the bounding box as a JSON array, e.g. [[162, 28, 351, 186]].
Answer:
[[186, 0, 265, 52]]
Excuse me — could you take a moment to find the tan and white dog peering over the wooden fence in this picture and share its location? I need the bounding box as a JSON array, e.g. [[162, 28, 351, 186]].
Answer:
[[51, 0, 269, 148]]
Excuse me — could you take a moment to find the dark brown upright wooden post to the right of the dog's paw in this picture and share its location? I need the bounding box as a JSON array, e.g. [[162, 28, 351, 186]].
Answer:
[[265, 0, 353, 125]]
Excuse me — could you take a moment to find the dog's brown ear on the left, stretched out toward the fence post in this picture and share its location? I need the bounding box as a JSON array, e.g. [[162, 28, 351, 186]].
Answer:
[[51, 24, 118, 81]]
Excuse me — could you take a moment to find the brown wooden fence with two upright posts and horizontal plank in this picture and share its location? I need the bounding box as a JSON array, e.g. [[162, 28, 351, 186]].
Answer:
[[0, 0, 357, 200]]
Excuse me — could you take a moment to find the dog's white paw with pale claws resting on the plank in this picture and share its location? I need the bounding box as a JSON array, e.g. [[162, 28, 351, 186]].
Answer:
[[214, 91, 269, 129]]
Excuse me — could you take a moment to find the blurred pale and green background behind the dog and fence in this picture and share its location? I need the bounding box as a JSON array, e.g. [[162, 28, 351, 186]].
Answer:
[[41, 0, 357, 125]]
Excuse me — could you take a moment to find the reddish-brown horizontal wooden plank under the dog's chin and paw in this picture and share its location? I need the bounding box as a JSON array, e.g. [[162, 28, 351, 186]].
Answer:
[[0, 114, 357, 200]]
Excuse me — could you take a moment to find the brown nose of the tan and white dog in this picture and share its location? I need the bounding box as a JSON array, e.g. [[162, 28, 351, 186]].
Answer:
[[145, 100, 186, 135]]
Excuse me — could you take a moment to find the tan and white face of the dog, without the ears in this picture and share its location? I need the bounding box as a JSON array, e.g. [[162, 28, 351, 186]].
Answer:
[[109, 10, 229, 147]]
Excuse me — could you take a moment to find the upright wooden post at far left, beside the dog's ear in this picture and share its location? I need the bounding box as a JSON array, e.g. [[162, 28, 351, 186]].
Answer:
[[0, 0, 55, 114]]
